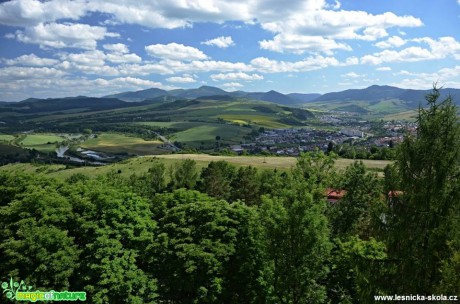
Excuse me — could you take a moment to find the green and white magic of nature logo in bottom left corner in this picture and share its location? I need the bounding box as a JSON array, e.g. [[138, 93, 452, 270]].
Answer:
[[2, 278, 86, 302]]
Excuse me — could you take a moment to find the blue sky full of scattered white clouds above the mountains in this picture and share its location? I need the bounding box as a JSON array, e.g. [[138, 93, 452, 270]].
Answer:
[[0, 0, 460, 101]]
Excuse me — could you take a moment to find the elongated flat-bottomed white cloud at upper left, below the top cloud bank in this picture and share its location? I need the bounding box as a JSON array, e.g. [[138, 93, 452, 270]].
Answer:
[[15, 23, 118, 50]]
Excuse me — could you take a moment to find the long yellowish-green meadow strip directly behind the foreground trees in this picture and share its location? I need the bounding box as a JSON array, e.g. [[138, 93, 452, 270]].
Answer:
[[0, 154, 391, 179]]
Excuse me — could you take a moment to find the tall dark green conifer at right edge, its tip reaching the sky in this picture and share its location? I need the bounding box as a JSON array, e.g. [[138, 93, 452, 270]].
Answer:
[[388, 87, 460, 293]]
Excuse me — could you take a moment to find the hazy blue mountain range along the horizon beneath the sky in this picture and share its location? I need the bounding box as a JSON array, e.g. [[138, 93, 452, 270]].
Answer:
[[0, 85, 460, 115]]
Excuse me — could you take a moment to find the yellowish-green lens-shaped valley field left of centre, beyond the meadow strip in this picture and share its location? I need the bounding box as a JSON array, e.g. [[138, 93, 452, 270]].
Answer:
[[80, 133, 168, 155]]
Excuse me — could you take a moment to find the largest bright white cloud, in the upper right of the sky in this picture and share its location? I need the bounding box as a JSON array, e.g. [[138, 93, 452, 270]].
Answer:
[[261, 10, 422, 54]]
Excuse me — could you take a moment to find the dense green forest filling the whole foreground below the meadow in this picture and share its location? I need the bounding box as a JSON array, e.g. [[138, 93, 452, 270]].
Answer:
[[0, 89, 460, 303]]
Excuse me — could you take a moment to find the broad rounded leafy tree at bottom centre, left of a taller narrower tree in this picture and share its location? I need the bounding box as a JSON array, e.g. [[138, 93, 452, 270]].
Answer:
[[147, 189, 261, 303]]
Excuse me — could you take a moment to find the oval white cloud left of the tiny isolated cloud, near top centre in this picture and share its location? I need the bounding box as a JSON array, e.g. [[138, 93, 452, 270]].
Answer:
[[145, 43, 208, 61]]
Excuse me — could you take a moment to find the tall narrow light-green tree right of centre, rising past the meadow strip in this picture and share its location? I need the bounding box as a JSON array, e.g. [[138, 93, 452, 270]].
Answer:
[[260, 154, 331, 303]]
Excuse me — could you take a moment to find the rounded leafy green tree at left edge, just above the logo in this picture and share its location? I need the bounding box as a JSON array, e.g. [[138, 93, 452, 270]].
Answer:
[[0, 176, 80, 289]]
